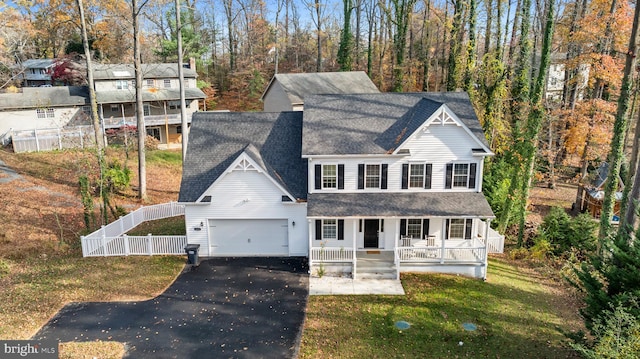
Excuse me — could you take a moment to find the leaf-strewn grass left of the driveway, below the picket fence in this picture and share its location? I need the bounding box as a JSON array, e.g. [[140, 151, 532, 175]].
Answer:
[[0, 255, 184, 340]]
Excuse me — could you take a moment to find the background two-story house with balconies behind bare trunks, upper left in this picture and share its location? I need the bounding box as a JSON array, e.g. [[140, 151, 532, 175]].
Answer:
[[94, 63, 206, 145]]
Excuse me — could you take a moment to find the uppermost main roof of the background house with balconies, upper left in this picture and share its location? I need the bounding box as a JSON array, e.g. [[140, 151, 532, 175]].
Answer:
[[93, 63, 197, 80]]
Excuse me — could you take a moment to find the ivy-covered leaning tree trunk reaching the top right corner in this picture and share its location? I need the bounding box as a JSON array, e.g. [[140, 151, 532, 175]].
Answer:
[[598, 0, 640, 240]]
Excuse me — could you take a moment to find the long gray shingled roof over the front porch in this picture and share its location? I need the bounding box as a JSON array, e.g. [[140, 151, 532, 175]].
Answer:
[[307, 192, 495, 218]]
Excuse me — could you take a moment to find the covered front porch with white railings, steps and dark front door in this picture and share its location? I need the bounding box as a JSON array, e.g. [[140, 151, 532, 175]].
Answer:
[[309, 193, 504, 279]]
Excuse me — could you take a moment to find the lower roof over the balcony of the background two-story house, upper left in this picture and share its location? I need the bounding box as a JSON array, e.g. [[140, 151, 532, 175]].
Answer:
[[96, 88, 207, 103]]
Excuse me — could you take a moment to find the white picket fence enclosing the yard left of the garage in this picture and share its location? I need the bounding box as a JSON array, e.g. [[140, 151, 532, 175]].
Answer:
[[80, 202, 187, 257]]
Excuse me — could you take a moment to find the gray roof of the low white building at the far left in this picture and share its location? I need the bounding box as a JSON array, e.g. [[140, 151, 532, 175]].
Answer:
[[0, 86, 89, 110]]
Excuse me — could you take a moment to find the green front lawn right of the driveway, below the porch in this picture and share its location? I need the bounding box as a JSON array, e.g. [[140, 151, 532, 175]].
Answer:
[[300, 260, 581, 358]]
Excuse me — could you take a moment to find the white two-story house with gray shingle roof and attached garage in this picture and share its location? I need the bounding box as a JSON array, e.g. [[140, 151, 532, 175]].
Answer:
[[179, 93, 503, 278]]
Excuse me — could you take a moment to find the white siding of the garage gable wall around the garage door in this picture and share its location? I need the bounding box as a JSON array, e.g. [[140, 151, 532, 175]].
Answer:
[[185, 171, 308, 256]]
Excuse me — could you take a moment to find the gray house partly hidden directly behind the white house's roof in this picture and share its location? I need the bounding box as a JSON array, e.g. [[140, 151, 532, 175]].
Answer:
[[260, 71, 380, 112]]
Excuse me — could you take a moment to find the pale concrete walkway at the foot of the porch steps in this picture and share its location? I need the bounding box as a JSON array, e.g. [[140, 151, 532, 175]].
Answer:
[[309, 276, 404, 295]]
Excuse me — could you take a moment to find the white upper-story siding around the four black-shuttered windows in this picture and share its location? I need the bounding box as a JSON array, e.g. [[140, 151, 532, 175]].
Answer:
[[308, 124, 483, 193]]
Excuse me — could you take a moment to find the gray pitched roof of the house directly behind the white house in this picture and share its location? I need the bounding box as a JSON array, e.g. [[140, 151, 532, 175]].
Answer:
[[260, 71, 380, 105]]
